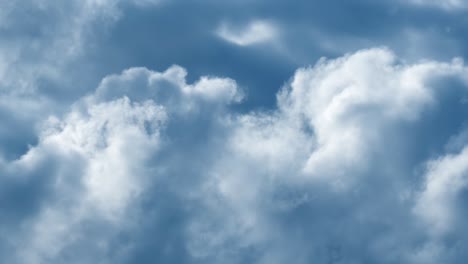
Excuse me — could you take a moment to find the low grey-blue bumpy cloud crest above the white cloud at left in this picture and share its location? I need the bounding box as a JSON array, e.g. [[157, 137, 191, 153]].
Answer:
[[95, 66, 243, 111]]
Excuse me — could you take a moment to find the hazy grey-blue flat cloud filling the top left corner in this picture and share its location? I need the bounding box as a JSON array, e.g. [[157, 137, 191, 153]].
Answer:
[[0, 0, 163, 99]]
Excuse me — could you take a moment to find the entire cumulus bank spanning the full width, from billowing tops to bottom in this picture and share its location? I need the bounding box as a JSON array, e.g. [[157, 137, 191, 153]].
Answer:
[[0, 48, 468, 263]]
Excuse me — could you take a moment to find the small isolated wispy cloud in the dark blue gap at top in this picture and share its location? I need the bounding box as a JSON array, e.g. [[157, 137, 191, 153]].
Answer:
[[216, 20, 278, 46]]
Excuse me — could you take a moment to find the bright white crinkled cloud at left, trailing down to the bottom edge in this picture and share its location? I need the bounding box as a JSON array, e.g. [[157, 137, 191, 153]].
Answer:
[[13, 97, 166, 263]]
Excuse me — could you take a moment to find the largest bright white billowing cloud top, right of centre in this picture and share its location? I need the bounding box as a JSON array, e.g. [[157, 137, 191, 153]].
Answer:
[[279, 49, 467, 188]]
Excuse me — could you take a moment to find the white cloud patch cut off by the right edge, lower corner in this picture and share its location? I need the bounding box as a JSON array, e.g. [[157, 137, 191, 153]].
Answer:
[[412, 142, 467, 263]]
